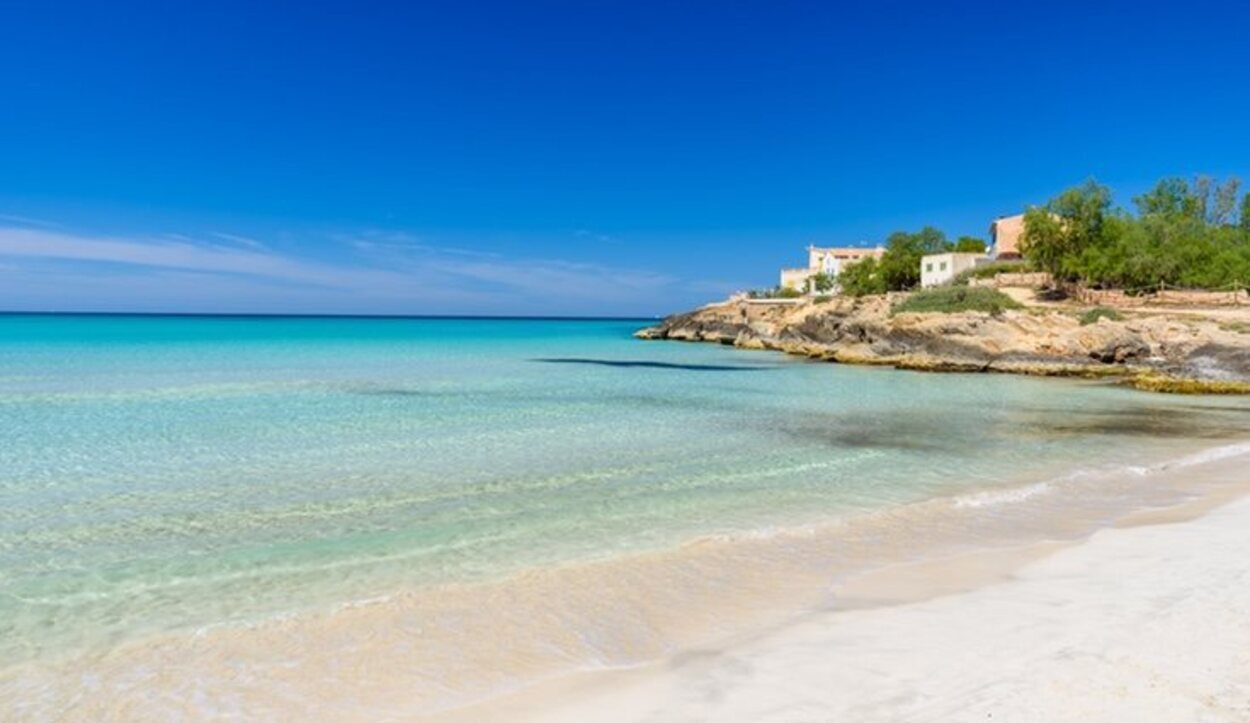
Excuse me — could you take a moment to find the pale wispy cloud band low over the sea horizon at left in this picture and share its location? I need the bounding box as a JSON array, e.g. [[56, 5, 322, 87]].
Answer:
[[0, 226, 676, 313]]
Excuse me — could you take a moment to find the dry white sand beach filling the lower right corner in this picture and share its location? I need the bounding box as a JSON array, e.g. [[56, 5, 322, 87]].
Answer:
[[438, 447, 1250, 723]]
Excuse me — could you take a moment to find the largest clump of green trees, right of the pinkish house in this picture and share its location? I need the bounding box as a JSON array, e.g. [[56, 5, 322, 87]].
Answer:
[[1020, 176, 1250, 291]]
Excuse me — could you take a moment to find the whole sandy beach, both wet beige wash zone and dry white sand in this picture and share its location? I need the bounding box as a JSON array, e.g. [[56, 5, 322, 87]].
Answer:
[[9, 438, 1250, 722]]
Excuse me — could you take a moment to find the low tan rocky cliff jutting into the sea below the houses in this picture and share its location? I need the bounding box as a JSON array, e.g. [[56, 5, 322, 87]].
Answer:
[[636, 296, 1250, 393]]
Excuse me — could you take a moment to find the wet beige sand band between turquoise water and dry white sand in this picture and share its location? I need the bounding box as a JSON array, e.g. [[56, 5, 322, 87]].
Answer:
[[0, 439, 1250, 722]]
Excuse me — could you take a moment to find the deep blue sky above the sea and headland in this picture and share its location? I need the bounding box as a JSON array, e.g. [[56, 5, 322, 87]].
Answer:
[[0, 0, 1250, 315]]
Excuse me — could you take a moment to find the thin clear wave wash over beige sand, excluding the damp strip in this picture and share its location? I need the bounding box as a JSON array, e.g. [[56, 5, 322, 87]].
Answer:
[[0, 435, 1250, 718]]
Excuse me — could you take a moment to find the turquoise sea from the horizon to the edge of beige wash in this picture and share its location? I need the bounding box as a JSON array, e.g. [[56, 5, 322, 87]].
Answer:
[[0, 315, 1250, 717]]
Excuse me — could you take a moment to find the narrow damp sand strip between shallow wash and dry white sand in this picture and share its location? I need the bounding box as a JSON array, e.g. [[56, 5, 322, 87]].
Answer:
[[427, 435, 1250, 723]]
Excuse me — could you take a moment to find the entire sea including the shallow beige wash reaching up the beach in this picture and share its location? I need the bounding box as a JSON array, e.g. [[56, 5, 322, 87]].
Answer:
[[0, 315, 1250, 719]]
